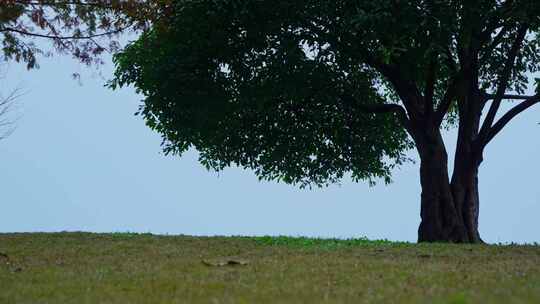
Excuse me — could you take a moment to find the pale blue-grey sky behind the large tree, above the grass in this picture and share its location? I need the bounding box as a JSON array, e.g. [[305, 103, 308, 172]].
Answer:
[[0, 57, 540, 243]]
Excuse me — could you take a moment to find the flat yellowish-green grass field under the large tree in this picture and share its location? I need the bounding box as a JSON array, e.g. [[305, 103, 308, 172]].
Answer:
[[0, 233, 540, 304]]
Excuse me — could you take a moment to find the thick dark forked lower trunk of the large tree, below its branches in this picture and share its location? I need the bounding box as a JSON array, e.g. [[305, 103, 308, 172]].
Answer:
[[415, 131, 481, 243]]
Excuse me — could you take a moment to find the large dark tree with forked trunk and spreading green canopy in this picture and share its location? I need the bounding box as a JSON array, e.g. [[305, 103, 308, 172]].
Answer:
[[111, 0, 540, 242]]
